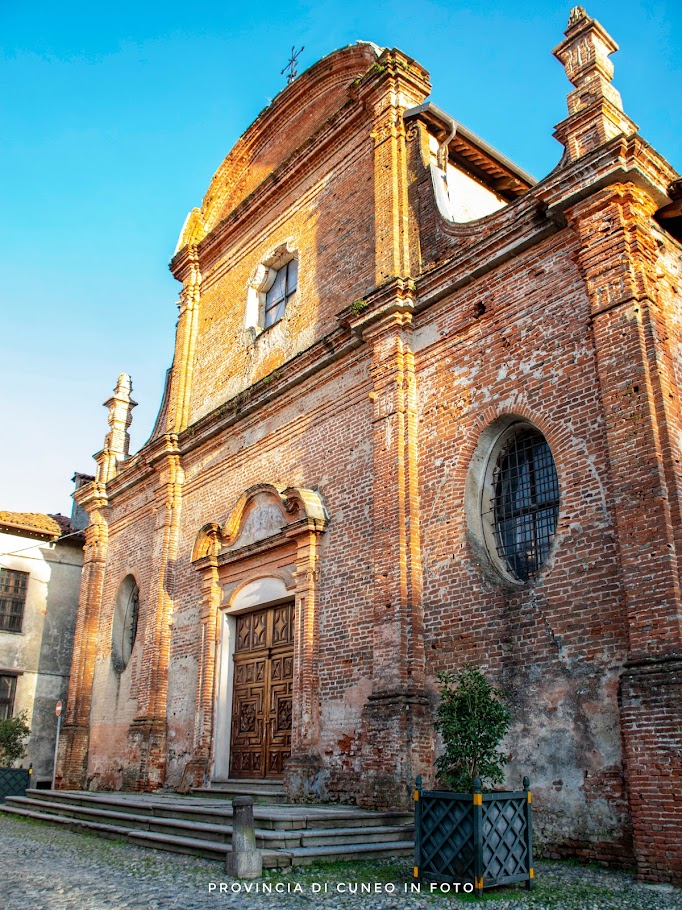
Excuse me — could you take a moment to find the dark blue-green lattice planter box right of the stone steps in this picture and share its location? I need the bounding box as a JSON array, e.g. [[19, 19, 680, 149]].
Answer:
[[414, 777, 533, 895]]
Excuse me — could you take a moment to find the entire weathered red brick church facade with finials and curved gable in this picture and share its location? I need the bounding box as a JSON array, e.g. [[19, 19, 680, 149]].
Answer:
[[60, 7, 682, 881]]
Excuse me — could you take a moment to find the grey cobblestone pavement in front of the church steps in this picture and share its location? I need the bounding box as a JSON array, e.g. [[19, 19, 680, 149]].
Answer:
[[0, 816, 682, 910]]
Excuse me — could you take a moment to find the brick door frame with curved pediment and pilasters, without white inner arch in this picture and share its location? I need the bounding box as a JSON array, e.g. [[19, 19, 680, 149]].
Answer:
[[191, 484, 328, 783]]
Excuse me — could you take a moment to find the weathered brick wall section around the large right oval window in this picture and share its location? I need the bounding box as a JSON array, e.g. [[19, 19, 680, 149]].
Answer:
[[417, 231, 629, 861]]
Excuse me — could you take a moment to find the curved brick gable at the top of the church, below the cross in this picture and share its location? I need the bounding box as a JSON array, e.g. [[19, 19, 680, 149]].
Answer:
[[178, 42, 380, 249]]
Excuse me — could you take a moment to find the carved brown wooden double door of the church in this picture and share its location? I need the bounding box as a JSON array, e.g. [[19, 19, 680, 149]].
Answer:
[[230, 603, 294, 778]]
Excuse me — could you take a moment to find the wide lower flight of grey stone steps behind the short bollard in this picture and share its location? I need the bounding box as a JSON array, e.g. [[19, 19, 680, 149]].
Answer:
[[0, 790, 414, 868]]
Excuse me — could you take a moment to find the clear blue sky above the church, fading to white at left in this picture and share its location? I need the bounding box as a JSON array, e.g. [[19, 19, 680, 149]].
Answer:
[[0, 0, 682, 514]]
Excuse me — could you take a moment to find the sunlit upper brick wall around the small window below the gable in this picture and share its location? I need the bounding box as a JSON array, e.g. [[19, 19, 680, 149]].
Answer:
[[189, 134, 374, 423]]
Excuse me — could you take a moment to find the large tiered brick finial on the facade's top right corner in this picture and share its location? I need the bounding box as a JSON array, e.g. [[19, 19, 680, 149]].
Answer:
[[553, 6, 637, 160]]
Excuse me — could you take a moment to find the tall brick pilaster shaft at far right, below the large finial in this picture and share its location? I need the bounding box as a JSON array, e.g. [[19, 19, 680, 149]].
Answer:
[[567, 185, 682, 660]]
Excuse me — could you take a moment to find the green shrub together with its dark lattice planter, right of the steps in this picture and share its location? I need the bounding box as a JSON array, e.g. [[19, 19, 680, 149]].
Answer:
[[414, 664, 533, 894]]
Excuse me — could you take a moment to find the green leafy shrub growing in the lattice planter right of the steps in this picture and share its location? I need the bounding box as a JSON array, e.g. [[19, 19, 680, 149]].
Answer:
[[435, 664, 511, 793]]
